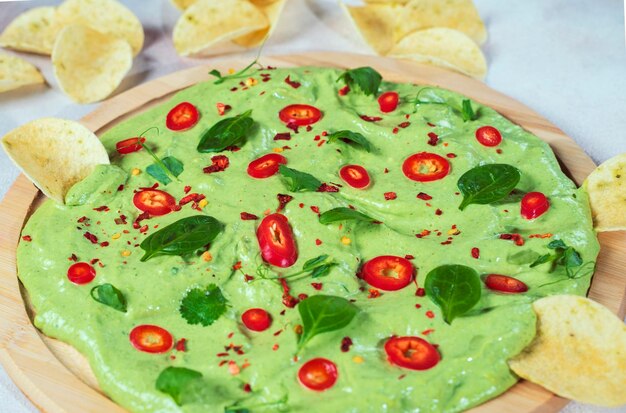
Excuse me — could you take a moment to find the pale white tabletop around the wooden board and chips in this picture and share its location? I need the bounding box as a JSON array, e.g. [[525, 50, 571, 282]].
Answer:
[[0, 0, 626, 413]]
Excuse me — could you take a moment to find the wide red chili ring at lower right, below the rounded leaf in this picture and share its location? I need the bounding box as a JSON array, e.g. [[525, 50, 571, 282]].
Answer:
[[385, 336, 441, 370]]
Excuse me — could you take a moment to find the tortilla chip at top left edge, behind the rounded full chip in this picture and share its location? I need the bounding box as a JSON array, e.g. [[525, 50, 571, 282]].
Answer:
[[57, 0, 144, 56]]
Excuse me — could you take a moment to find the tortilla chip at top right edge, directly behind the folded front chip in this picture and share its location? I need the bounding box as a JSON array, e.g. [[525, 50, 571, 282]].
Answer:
[[394, 0, 487, 44]]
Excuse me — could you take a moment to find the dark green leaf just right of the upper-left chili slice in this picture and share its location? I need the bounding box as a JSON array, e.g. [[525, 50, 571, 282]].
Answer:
[[197, 110, 254, 153]]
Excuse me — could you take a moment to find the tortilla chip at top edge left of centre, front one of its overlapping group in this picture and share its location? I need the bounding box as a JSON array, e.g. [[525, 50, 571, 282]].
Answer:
[[173, 0, 269, 56]]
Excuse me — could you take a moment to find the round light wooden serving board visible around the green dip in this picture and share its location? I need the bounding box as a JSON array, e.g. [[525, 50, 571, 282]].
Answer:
[[0, 52, 626, 413]]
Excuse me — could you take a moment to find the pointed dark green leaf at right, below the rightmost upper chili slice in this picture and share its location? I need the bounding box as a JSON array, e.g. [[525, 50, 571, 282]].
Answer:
[[457, 163, 521, 211]]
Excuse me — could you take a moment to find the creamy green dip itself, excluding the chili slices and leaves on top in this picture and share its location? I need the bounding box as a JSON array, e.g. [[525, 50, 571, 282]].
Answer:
[[17, 68, 599, 413]]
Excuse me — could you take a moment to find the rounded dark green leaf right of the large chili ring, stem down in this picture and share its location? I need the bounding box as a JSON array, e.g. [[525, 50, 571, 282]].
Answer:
[[424, 265, 482, 324]]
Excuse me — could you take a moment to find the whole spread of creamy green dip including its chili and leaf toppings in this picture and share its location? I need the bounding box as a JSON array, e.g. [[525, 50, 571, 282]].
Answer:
[[17, 68, 599, 413]]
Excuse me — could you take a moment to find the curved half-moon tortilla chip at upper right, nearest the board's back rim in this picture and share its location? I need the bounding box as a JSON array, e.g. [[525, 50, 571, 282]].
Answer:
[[389, 27, 487, 79]]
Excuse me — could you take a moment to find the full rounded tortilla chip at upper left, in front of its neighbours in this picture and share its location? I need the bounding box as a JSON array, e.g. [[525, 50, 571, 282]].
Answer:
[[52, 25, 133, 103]]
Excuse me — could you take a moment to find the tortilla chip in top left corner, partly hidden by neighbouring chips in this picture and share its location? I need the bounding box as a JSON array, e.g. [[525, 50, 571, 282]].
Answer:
[[0, 7, 59, 55]]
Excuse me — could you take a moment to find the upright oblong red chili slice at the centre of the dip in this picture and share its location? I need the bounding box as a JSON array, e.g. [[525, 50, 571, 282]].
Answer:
[[256, 214, 298, 268]]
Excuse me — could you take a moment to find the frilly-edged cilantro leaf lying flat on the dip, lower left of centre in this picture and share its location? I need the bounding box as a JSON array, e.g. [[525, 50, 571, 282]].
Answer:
[[178, 284, 226, 327]]
